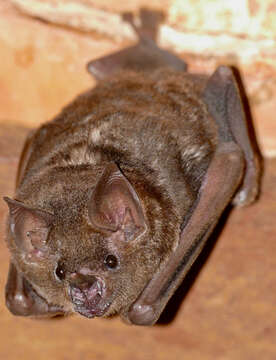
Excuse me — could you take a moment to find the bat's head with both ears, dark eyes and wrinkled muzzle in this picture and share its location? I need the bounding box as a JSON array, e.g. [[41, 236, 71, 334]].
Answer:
[[3, 163, 177, 317]]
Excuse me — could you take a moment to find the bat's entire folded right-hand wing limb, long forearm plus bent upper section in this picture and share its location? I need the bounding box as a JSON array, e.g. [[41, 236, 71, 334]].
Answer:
[[124, 67, 258, 325]]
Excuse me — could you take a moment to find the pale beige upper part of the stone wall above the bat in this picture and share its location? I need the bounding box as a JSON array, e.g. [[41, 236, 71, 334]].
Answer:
[[0, 0, 276, 156]]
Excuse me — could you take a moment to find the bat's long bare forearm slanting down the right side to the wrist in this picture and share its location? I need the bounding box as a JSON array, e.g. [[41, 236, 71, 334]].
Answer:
[[127, 142, 244, 325]]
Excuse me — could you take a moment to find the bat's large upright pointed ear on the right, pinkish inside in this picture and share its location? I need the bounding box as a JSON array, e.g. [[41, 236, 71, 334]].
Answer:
[[88, 163, 146, 241]]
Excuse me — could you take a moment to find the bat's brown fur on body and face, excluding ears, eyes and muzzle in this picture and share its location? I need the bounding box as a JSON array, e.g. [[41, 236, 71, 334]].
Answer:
[[4, 69, 216, 315]]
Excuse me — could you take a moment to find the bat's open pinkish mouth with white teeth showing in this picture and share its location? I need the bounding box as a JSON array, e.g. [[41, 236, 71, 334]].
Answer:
[[69, 277, 110, 318]]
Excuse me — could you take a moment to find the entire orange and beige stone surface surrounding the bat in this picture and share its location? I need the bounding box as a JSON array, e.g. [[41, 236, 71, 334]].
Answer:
[[0, 0, 276, 360]]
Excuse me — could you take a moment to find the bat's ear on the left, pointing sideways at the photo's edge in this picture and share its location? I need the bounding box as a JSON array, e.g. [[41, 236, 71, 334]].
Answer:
[[4, 197, 53, 257]]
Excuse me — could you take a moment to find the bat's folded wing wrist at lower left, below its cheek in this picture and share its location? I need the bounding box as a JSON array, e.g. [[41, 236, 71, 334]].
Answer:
[[6, 262, 64, 317]]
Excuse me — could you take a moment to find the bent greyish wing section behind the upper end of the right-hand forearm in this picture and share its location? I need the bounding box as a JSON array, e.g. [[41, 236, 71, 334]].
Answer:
[[203, 66, 260, 206]]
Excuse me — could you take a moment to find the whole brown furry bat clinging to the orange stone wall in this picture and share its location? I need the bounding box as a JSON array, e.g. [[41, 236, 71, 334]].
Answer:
[[4, 11, 260, 325]]
